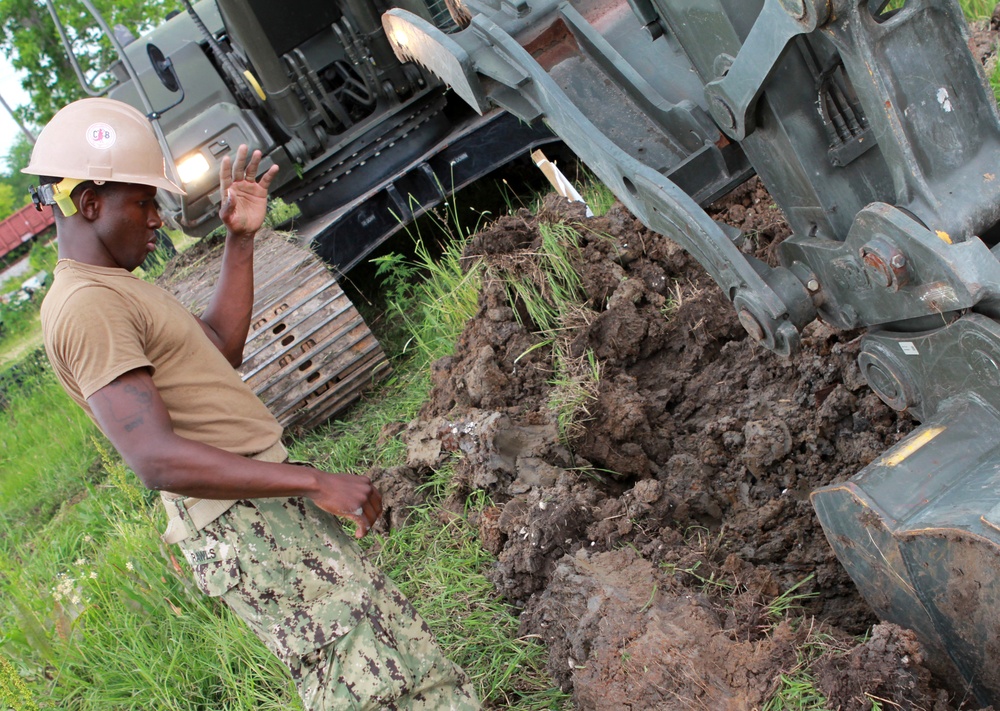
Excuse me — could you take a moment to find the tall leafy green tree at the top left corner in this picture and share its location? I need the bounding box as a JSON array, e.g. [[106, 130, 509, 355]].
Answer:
[[0, 0, 179, 126]]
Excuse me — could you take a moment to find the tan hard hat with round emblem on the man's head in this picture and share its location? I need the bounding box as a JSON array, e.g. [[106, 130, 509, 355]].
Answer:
[[21, 98, 185, 195]]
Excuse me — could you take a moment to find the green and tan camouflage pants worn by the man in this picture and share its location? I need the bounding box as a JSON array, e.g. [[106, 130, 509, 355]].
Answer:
[[180, 498, 479, 711]]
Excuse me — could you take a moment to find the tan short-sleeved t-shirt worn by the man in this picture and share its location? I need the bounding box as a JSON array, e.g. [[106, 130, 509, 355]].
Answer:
[[42, 259, 281, 455]]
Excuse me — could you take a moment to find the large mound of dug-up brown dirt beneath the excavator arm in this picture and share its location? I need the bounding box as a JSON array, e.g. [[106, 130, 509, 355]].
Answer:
[[380, 186, 992, 711]]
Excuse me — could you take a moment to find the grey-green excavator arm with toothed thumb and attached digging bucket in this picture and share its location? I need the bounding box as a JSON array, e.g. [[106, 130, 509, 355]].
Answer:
[[383, 0, 1000, 705]]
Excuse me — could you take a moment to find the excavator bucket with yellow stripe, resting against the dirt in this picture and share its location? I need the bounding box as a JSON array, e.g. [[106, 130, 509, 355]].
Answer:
[[812, 396, 1000, 705]]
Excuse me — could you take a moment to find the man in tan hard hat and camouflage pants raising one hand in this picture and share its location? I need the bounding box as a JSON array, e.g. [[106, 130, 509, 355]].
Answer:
[[24, 99, 478, 709]]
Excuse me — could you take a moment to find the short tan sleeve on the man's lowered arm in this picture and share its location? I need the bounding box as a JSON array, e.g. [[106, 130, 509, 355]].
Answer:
[[46, 286, 153, 400]]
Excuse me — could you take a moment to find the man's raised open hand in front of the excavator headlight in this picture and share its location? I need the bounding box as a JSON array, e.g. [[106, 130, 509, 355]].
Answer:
[[219, 144, 278, 235]]
